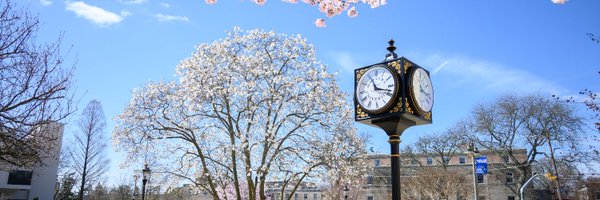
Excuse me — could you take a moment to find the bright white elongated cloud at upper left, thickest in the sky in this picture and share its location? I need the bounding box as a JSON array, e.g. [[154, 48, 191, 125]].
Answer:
[[66, 1, 130, 26]]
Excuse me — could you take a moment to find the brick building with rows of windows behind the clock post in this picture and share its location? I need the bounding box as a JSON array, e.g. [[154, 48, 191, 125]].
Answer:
[[359, 149, 526, 200]]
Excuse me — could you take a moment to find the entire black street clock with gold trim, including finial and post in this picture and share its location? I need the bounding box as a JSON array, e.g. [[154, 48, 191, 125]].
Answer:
[[354, 40, 433, 200]]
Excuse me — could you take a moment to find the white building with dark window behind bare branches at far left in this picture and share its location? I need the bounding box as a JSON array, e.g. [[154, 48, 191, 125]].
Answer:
[[0, 123, 64, 200]]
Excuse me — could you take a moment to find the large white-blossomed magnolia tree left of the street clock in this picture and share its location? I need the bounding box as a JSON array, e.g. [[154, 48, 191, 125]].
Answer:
[[113, 28, 368, 200]]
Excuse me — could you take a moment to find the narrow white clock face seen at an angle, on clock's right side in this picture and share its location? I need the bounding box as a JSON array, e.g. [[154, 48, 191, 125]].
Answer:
[[410, 68, 433, 112]]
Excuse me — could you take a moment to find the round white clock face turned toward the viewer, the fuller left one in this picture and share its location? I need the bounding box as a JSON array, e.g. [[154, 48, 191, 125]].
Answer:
[[356, 66, 398, 113]]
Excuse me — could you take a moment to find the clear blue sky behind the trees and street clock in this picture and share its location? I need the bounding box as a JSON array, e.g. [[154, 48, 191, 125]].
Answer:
[[17, 0, 600, 184]]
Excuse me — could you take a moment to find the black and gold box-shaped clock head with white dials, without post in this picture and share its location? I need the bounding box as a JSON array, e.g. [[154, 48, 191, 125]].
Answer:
[[354, 44, 434, 128]]
